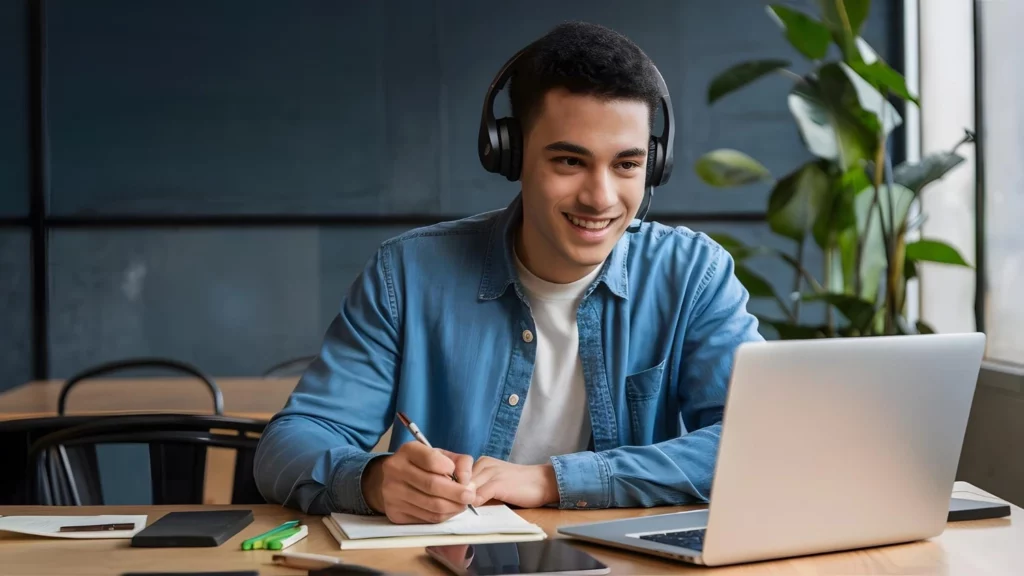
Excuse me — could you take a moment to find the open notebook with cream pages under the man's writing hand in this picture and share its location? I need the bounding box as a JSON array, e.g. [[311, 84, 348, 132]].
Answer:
[[324, 504, 547, 550]]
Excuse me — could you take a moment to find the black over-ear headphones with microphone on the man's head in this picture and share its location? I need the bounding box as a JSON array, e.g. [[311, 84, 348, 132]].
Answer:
[[477, 46, 676, 233]]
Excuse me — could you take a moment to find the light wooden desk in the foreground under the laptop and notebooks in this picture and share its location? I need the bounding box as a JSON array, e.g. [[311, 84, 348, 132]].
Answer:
[[0, 483, 1024, 576]]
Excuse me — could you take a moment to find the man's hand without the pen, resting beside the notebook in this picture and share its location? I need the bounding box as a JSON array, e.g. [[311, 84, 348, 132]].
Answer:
[[473, 456, 558, 508]]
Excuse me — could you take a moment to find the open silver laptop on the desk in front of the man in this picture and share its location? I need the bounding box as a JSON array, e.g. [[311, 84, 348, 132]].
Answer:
[[558, 333, 985, 566]]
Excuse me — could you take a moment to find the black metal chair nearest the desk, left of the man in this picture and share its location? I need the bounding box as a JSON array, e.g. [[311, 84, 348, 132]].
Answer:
[[28, 414, 266, 505]]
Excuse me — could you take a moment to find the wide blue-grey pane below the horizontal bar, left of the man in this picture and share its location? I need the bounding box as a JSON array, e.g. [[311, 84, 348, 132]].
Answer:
[[49, 228, 403, 377]]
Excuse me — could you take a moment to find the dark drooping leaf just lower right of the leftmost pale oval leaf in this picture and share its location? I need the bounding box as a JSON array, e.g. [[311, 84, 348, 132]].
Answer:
[[768, 162, 828, 241]]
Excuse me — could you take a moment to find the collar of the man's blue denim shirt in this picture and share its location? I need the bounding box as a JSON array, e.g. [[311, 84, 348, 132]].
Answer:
[[478, 194, 630, 300]]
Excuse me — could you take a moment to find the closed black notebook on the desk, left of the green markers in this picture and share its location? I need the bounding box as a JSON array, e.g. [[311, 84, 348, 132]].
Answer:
[[131, 510, 253, 548]]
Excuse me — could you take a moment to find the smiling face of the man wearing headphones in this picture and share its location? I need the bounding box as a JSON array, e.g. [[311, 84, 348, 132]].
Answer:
[[516, 89, 650, 283]]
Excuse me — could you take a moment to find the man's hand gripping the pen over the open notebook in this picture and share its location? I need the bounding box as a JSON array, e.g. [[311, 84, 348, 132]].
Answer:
[[362, 442, 476, 524]]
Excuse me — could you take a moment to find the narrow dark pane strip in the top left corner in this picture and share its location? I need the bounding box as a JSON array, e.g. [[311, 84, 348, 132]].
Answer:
[[0, 0, 29, 217]]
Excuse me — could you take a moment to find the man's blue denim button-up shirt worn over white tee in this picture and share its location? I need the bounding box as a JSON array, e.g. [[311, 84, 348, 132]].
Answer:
[[254, 197, 762, 515]]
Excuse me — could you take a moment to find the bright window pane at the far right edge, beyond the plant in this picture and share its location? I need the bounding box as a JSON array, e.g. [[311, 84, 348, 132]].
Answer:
[[976, 2, 1024, 364]]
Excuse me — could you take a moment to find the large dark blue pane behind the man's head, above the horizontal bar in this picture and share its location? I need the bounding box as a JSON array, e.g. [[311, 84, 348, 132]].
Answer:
[[46, 0, 897, 215]]
